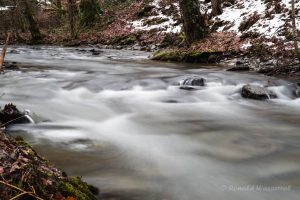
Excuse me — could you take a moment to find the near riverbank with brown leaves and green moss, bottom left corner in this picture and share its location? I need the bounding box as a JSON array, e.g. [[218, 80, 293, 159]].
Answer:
[[0, 105, 100, 200]]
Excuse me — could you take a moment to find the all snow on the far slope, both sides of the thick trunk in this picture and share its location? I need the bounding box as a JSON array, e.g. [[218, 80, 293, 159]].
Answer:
[[128, 0, 300, 38]]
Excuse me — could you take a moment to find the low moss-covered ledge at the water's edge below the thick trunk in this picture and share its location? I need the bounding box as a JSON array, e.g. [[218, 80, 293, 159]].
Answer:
[[152, 50, 222, 63]]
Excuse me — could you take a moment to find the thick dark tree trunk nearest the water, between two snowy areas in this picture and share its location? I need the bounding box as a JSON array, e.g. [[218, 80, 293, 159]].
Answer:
[[179, 0, 207, 45]]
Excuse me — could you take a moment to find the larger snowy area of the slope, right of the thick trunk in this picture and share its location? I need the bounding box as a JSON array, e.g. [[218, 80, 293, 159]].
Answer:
[[214, 0, 300, 38]]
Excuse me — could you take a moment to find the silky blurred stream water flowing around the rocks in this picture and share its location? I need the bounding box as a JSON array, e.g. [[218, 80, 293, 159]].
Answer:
[[0, 47, 300, 200]]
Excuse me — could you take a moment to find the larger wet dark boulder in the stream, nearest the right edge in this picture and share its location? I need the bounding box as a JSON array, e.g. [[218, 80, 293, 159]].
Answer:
[[242, 85, 277, 100]]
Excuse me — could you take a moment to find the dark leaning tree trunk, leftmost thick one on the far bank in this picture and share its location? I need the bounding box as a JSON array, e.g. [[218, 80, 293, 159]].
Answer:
[[18, 0, 42, 41]]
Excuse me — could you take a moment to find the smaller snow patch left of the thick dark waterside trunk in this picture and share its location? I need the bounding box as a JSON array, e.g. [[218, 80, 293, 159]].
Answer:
[[128, 0, 181, 33]]
